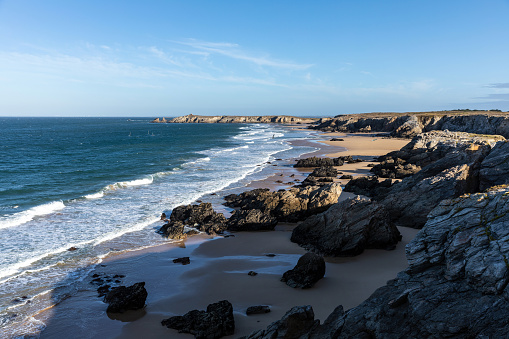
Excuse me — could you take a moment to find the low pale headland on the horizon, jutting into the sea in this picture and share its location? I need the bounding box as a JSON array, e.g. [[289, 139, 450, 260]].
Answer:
[[155, 114, 318, 124]]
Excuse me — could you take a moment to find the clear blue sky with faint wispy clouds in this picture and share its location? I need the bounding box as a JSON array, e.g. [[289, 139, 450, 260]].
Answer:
[[0, 0, 509, 117]]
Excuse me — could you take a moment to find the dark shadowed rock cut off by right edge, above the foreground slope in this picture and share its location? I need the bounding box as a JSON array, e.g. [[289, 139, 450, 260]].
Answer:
[[479, 141, 509, 191]]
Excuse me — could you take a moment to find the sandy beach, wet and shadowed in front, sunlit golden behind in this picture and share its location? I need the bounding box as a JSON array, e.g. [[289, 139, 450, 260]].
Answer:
[[38, 133, 417, 338]]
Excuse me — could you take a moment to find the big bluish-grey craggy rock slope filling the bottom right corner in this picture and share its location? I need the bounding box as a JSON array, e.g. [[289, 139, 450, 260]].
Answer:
[[249, 188, 509, 339]]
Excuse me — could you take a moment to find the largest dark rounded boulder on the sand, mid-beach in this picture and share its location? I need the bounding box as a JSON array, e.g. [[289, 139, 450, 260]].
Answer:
[[291, 196, 401, 256]]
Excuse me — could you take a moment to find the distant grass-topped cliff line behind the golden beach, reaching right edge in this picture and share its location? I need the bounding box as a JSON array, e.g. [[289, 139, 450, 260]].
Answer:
[[313, 112, 509, 138]]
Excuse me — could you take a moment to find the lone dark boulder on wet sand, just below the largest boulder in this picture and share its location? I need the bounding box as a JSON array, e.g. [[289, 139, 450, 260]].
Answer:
[[281, 253, 325, 288]]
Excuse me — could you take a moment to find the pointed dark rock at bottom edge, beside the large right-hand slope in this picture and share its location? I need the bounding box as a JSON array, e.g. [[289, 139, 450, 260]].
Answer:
[[241, 305, 320, 339]]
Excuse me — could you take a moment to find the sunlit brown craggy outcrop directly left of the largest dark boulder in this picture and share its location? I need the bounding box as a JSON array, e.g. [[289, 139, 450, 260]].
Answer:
[[225, 183, 341, 222]]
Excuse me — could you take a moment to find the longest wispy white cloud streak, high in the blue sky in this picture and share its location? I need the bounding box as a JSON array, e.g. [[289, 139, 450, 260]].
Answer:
[[173, 39, 313, 70]]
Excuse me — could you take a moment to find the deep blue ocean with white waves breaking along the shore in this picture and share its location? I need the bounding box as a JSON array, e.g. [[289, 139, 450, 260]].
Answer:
[[0, 118, 313, 337]]
